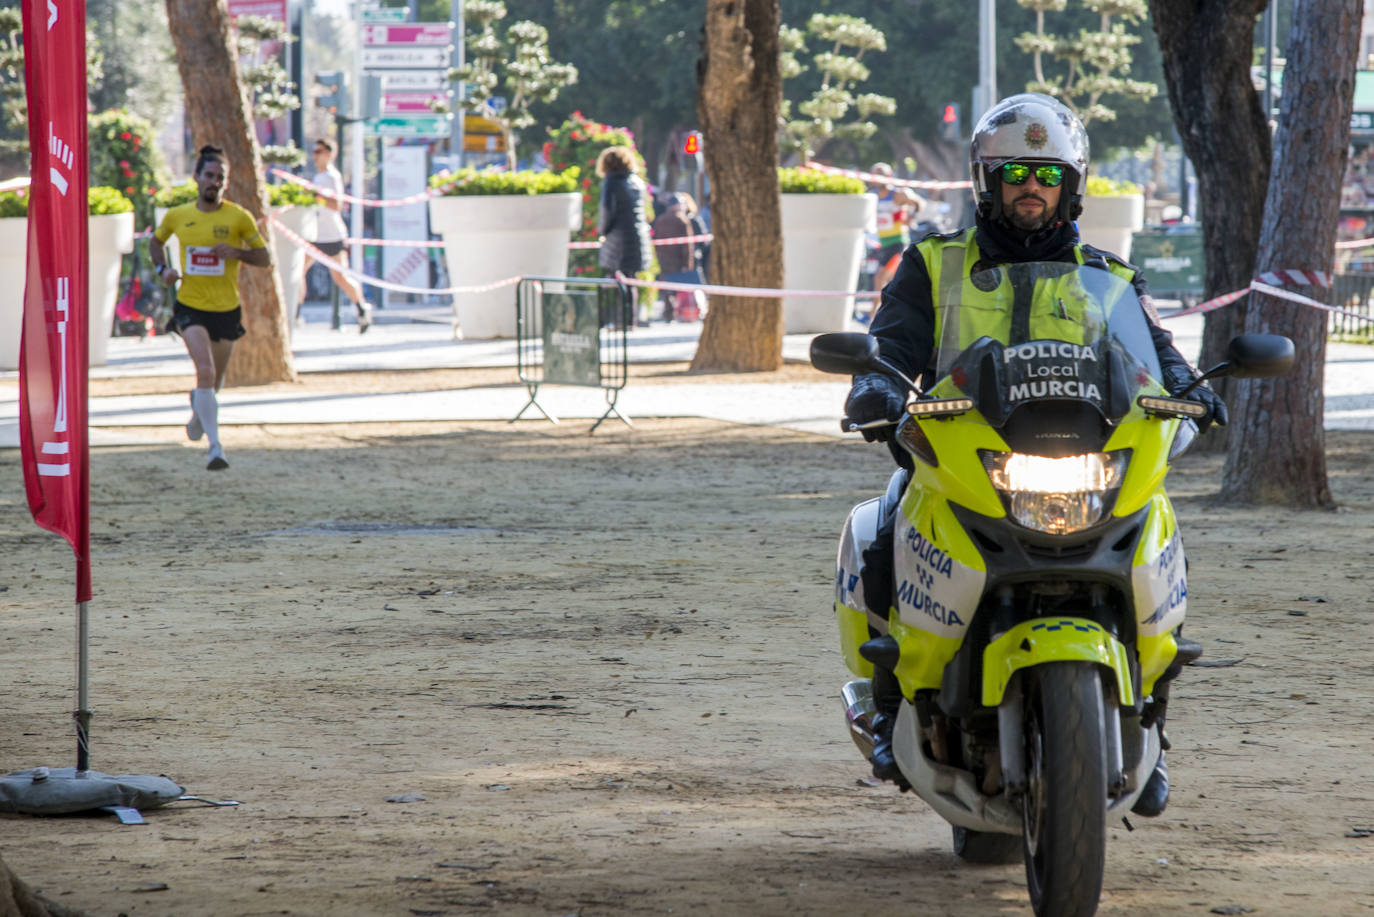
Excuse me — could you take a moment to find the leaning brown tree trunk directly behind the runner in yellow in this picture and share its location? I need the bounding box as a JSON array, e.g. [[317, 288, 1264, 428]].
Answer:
[[166, 0, 295, 385]]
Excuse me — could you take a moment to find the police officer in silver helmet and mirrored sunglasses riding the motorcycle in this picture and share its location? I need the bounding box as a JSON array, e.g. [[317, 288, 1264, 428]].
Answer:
[[845, 92, 1227, 815]]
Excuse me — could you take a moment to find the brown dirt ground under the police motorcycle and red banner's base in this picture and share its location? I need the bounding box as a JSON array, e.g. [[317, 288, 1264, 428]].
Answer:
[[0, 373, 1374, 917]]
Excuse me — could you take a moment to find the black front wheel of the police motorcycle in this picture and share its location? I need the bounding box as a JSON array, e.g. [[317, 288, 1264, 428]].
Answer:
[[1021, 663, 1107, 917]]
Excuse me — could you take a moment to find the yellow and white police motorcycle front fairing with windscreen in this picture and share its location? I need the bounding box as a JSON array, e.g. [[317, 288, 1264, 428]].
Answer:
[[888, 263, 1187, 715]]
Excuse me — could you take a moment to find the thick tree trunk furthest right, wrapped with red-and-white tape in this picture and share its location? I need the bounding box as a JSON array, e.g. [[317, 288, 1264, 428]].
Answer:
[[1221, 0, 1362, 507]]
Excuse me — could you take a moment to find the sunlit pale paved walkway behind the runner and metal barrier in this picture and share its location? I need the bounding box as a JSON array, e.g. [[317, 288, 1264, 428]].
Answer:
[[0, 305, 1374, 447]]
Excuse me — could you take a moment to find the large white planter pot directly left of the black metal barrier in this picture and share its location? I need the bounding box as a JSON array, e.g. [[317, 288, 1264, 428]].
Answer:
[[429, 192, 583, 340]]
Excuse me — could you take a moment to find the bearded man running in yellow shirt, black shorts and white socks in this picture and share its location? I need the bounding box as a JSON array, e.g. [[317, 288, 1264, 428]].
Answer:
[[150, 146, 272, 472]]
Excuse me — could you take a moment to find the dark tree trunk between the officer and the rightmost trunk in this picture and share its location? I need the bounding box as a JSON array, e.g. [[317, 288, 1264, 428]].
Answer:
[[1146, 0, 1271, 452]]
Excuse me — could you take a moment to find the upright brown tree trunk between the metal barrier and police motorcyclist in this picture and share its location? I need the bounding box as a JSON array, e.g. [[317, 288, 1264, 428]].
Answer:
[[691, 0, 782, 371]]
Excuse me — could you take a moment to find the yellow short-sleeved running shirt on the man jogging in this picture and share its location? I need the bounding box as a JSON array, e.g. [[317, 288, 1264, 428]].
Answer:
[[154, 201, 267, 312]]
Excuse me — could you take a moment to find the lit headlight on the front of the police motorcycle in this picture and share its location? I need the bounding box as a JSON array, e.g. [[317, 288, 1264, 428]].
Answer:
[[978, 450, 1131, 535]]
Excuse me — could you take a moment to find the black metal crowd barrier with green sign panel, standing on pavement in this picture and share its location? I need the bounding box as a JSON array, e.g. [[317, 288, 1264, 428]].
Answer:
[[511, 276, 633, 433]]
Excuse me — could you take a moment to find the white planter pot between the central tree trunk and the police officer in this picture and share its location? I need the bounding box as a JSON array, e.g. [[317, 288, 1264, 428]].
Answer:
[[782, 194, 878, 334]]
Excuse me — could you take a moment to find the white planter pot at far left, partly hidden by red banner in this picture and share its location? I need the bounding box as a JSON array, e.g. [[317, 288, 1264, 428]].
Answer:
[[0, 213, 133, 370]]
